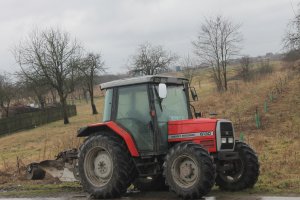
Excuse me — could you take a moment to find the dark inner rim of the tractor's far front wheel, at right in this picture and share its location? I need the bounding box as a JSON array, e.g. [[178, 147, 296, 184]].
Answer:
[[220, 159, 244, 183]]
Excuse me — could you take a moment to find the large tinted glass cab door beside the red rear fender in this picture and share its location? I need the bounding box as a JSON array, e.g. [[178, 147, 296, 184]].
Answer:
[[115, 84, 154, 154]]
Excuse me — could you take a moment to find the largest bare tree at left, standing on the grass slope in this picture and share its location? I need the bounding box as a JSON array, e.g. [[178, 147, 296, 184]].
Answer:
[[14, 28, 81, 124]]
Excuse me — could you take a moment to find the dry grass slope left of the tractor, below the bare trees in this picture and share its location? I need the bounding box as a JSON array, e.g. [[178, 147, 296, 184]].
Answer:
[[0, 97, 103, 170]]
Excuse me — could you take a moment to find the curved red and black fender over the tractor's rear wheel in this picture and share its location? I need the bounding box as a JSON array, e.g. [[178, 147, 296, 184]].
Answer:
[[77, 122, 139, 157]]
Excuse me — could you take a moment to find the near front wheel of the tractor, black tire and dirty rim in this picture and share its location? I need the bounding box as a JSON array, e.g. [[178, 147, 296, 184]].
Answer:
[[164, 142, 215, 199]]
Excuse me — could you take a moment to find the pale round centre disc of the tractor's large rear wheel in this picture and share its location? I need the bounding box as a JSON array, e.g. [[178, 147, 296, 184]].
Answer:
[[94, 152, 112, 179]]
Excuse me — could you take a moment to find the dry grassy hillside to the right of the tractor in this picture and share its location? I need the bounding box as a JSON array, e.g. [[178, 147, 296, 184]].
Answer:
[[196, 64, 300, 193]]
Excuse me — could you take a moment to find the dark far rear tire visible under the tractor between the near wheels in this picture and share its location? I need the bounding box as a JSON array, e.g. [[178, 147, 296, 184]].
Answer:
[[133, 174, 169, 192]]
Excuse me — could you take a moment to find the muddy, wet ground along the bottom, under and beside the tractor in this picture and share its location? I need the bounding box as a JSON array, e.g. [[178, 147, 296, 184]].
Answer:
[[0, 169, 300, 200]]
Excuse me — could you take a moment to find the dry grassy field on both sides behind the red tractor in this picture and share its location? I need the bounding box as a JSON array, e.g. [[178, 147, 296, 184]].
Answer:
[[0, 62, 300, 194]]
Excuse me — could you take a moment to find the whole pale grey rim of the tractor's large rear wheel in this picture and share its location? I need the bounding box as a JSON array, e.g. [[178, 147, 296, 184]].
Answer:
[[84, 147, 113, 187]]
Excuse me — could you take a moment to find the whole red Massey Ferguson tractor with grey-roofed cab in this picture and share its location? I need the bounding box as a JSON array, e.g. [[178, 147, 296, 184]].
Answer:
[[28, 76, 259, 199]]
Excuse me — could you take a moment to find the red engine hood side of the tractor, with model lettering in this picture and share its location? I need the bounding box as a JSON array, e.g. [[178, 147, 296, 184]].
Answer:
[[168, 118, 217, 152]]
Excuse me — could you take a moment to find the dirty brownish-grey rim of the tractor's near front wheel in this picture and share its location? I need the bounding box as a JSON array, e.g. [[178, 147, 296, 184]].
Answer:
[[171, 155, 200, 188]]
